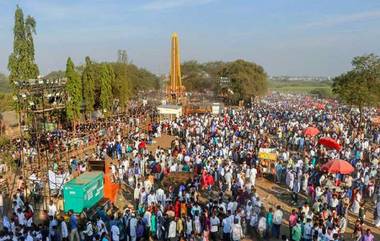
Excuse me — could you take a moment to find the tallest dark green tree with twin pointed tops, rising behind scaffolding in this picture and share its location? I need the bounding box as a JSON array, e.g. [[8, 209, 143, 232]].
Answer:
[[8, 6, 39, 85]]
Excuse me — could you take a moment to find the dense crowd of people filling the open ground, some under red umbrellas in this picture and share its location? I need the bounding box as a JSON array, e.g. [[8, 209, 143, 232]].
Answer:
[[0, 95, 380, 241]]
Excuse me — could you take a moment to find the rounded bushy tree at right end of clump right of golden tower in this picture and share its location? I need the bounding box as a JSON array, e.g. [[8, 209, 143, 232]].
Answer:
[[219, 60, 268, 102]]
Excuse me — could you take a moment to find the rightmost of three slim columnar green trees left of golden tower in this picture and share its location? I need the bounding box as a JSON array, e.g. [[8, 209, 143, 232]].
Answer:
[[100, 64, 114, 111]]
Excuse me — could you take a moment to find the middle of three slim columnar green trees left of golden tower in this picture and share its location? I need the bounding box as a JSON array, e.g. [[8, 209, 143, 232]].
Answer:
[[82, 56, 95, 114]]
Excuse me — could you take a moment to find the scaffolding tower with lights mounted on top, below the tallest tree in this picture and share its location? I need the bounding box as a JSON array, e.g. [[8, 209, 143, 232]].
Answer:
[[13, 78, 68, 206]]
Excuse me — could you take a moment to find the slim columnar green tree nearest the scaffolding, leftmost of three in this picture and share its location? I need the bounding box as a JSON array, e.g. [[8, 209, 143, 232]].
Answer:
[[65, 58, 83, 121]]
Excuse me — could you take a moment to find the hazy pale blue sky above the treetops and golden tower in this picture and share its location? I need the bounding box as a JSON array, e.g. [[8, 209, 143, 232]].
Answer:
[[0, 0, 380, 76]]
